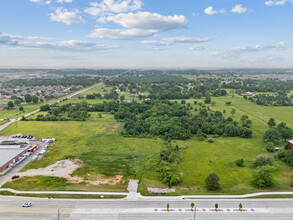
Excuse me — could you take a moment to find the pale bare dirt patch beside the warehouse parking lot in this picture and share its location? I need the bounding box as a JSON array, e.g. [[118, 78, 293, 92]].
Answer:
[[19, 160, 123, 186]]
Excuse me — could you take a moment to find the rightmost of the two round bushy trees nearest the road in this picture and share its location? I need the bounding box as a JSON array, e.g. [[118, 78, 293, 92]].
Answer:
[[252, 166, 273, 188]]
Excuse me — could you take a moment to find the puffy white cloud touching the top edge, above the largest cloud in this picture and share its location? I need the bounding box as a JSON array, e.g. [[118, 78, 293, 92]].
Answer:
[[85, 0, 142, 16]]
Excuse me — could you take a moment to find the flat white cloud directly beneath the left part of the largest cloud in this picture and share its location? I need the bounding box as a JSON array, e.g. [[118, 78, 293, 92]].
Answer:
[[88, 28, 156, 40]]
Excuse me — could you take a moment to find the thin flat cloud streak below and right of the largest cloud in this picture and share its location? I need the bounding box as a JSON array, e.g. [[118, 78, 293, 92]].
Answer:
[[142, 37, 211, 46]]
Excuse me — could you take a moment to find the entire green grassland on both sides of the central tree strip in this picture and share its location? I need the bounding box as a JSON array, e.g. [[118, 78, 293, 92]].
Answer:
[[0, 96, 293, 195]]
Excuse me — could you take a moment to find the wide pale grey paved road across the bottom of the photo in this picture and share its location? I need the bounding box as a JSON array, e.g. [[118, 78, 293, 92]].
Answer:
[[0, 196, 293, 220]]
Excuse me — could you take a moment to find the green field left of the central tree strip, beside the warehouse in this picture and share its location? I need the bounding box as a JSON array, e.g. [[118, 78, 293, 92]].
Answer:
[[0, 113, 162, 191]]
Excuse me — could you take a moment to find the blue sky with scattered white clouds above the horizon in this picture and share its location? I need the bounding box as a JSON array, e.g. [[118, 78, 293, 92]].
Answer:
[[0, 0, 293, 68]]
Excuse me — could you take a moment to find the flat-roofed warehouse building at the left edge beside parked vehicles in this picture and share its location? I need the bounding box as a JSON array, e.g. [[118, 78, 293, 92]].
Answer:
[[0, 147, 25, 173]]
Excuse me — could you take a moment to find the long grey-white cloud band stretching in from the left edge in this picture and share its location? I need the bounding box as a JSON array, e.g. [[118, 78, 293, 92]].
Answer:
[[0, 33, 119, 52]]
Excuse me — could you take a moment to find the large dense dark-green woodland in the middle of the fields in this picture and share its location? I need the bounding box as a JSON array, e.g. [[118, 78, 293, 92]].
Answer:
[[114, 101, 252, 140]]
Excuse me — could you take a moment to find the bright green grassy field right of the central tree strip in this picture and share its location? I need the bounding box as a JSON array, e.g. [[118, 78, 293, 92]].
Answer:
[[139, 96, 293, 195]]
